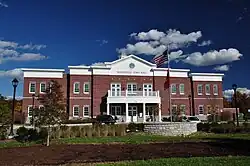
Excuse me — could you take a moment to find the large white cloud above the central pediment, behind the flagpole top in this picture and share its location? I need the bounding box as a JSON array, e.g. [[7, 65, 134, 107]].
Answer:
[[117, 29, 202, 55]]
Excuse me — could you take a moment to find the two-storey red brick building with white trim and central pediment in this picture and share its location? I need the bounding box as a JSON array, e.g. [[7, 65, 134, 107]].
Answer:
[[23, 55, 224, 122]]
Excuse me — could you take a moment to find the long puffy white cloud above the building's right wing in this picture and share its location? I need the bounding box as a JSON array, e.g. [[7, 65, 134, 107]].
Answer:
[[183, 48, 242, 66]]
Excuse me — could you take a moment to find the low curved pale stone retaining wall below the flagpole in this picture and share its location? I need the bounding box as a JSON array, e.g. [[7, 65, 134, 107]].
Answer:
[[144, 122, 197, 136]]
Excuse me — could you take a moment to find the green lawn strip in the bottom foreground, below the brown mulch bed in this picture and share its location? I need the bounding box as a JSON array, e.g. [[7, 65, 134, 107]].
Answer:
[[97, 156, 250, 166]]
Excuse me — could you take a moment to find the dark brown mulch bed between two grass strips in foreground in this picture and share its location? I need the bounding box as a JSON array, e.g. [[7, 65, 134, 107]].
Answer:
[[0, 140, 250, 166]]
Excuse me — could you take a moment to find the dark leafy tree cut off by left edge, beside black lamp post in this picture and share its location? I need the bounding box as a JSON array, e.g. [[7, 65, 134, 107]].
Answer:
[[0, 103, 11, 139]]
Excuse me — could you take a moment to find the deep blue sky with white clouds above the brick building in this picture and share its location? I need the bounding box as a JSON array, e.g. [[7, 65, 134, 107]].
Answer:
[[0, 0, 250, 96]]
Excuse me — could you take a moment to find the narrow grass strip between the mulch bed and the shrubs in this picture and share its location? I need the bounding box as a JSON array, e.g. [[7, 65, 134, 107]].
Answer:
[[0, 132, 250, 148]]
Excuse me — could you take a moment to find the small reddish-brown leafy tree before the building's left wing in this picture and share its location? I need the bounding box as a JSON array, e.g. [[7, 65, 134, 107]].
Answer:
[[33, 80, 67, 146]]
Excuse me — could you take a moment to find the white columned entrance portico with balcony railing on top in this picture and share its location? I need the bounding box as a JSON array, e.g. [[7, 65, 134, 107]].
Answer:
[[107, 90, 161, 123]]
